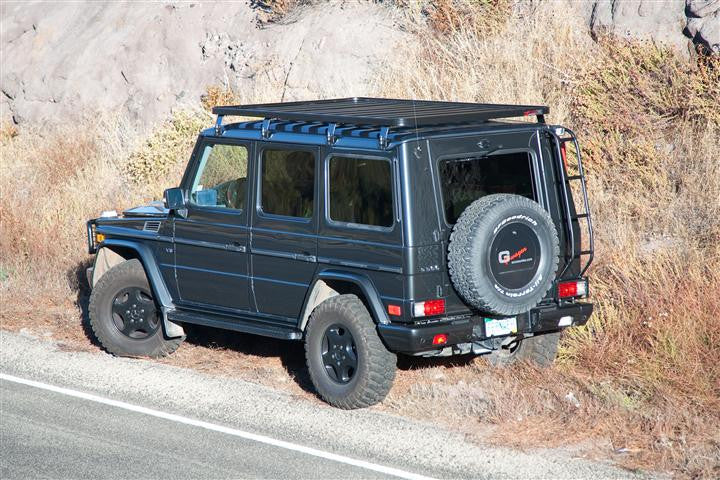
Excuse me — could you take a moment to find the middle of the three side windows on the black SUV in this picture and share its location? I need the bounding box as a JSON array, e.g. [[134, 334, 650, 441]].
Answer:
[[260, 150, 315, 218]]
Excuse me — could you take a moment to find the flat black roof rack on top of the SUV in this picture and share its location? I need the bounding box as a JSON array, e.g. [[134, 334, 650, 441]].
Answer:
[[212, 97, 550, 128]]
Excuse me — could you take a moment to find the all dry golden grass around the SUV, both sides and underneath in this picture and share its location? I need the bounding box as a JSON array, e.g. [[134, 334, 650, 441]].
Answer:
[[0, 1, 720, 477]]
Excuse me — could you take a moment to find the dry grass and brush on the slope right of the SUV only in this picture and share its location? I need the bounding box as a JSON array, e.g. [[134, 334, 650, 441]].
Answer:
[[378, 2, 720, 477]]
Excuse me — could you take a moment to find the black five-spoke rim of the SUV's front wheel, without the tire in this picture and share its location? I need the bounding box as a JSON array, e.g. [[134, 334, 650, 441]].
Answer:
[[112, 287, 160, 340]]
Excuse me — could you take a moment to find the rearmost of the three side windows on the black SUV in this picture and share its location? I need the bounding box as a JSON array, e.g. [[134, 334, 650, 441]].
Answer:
[[329, 157, 393, 227]]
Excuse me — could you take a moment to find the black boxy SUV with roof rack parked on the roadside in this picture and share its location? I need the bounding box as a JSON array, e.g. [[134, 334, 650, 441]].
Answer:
[[87, 98, 593, 408]]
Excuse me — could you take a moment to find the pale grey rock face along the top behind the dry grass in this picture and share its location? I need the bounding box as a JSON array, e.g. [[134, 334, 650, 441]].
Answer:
[[0, 0, 720, 131]]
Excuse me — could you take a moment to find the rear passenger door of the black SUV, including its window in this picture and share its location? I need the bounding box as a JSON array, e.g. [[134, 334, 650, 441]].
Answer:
[[251, 145, 318, 323]]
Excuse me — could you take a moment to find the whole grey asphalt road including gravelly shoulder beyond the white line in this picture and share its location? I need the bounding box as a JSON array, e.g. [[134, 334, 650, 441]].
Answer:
[[0, 330, 643, 479]]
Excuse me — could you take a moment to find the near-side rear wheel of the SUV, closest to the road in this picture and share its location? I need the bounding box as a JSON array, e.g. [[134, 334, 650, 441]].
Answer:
[[305, 295, 397, 410]]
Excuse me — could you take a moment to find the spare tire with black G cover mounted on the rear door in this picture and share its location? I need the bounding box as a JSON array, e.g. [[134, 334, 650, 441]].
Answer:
[[448, 194, 560, 315]]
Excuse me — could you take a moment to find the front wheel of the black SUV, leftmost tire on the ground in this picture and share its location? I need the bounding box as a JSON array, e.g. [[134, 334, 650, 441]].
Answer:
[[89, 259, 183, 357]]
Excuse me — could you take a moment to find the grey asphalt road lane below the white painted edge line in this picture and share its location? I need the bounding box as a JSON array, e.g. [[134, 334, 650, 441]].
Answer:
[[0, 380, 391, 479]]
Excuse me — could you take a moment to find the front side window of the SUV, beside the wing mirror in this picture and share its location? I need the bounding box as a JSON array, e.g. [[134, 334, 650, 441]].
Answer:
[[190, 144, 248, 210]]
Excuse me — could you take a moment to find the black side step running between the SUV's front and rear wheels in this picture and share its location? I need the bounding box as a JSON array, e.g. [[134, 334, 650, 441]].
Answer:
[[168, 310, 302, 340]]
